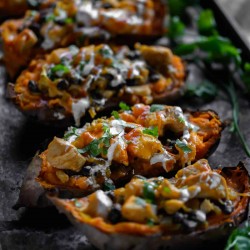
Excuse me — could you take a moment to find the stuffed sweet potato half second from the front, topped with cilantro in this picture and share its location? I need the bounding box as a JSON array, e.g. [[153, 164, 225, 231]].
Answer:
[[21, 104, 222, 195]]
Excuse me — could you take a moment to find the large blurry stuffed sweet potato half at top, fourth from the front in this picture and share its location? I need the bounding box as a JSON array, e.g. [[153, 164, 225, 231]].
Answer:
[[1, 0, 166, 77]]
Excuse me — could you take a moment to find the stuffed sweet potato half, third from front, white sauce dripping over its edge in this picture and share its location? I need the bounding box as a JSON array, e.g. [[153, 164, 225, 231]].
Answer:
[[9, 44, 185, 126]]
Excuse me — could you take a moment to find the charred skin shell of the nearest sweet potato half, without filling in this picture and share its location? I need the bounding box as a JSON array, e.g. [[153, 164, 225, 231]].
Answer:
[[49, 162, 249, 250]]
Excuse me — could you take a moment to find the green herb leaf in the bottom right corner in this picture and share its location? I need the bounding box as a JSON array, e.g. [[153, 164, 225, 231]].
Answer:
[[225, 223, 250, 250]]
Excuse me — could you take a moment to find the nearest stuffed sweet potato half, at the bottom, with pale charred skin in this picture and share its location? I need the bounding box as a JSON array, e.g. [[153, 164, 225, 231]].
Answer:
[[51, 159, 249, 250]]
